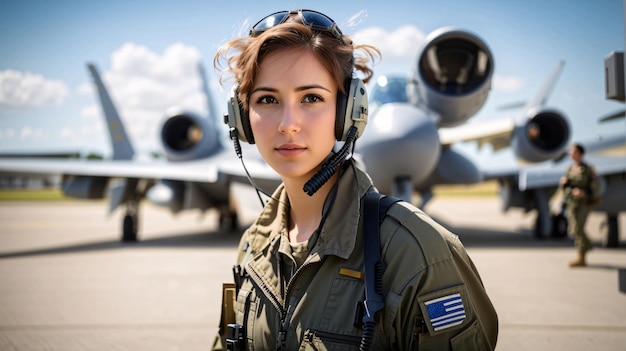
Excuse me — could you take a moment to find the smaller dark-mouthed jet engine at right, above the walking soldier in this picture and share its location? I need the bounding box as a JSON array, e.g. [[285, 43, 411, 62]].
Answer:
[[511, 110, 570, 163]]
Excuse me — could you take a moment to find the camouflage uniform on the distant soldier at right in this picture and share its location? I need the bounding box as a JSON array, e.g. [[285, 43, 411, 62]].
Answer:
[[563, 162, 595, 252]]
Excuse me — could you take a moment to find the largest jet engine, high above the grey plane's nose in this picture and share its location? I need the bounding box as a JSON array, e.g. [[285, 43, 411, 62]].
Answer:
[[409, 27, 494, 127]]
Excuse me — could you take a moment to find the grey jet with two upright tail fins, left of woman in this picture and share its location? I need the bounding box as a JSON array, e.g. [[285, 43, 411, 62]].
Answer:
[[0, 64, 278, 242]]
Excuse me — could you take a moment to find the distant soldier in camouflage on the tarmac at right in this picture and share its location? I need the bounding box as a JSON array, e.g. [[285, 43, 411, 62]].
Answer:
[[561, 144, 599, 267]]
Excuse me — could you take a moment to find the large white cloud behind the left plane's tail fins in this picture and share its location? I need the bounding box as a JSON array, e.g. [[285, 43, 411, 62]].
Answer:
[[85, 43, 207, 150]]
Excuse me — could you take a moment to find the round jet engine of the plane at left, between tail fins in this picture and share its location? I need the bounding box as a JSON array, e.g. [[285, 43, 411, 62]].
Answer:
[[161, 112, 221, 161]]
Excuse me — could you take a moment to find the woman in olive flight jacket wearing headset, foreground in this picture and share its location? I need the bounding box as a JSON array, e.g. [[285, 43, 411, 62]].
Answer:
[[215, 10, 497, 350]]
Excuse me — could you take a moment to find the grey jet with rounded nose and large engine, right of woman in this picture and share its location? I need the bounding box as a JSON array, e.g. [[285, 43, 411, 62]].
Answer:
[[355, 27, 571, 223]]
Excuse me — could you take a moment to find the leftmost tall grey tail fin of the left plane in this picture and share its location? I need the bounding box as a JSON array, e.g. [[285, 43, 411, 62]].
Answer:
[[87, 63, 135, 160]]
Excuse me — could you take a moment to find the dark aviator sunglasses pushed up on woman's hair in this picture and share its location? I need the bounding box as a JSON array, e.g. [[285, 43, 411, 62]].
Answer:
[[250, 10, 344, 44]]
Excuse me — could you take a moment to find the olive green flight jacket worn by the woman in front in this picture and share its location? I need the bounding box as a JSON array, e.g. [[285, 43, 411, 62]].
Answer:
[[216, 167, 498, 350]]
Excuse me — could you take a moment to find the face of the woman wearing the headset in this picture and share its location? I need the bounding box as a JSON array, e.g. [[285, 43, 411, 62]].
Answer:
[[249, 49, 337, 181]]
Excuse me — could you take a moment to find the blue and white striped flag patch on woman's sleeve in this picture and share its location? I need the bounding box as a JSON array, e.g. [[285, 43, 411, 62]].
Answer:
[[424, 293, 465, 331]]
